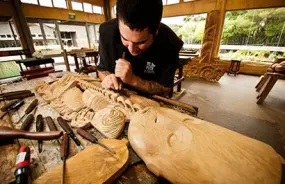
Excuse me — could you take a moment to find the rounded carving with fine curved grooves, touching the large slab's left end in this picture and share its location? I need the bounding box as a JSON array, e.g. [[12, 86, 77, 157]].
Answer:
[[91, 107, 125, 138]]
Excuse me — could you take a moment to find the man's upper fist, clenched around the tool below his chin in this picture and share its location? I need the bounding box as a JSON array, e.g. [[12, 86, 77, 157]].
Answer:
[[115, 59, 136, 85]]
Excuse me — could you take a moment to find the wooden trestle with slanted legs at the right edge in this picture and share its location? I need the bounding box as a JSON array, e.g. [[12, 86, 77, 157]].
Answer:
[[255, 58, 285, 104]]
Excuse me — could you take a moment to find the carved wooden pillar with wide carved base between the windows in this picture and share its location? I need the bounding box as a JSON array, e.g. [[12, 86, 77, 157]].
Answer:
[[184, 10, 226, 82]]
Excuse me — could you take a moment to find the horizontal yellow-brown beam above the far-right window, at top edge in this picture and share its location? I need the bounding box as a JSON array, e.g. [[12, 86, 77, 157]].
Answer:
[[225, 0, 285, 10]]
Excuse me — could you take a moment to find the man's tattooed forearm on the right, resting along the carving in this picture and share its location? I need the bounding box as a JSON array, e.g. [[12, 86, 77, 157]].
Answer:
[[131, 77, 171, 96]]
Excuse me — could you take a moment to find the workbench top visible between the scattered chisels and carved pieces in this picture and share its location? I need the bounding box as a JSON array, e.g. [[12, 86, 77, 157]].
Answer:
[[0, 77, 191, 184]]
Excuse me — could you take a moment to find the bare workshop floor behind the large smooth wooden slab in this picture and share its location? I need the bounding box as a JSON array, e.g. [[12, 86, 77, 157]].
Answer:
[[179, 75, 285, 158]]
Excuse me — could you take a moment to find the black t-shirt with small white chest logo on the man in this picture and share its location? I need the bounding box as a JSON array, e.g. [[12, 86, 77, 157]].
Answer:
[[97, 19, 183, 87]]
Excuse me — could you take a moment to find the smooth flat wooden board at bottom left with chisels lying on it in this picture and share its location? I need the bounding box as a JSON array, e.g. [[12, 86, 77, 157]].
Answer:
[[33, 139, 129, 184]]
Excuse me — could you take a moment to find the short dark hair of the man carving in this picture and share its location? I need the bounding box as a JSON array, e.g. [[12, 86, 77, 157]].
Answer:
[[117, 0, 163, 34]]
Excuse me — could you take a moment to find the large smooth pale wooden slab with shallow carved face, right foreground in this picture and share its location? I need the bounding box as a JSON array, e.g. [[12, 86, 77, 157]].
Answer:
[[128, 107, 281, 184]]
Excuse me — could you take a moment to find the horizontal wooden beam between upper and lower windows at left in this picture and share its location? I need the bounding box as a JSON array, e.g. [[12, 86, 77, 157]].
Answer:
[[21, 3, 106, 23]]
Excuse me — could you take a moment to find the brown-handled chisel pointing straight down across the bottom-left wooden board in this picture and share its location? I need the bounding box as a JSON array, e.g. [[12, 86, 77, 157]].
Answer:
[[60, 133, 69, 184]]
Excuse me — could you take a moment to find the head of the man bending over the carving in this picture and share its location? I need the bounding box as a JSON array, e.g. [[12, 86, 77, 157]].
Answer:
[[117, 0, 163, 56]]
